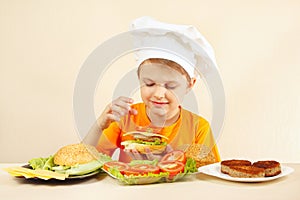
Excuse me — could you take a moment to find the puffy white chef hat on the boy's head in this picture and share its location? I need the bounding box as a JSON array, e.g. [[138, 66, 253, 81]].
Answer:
[[130, 16, 217, 78]]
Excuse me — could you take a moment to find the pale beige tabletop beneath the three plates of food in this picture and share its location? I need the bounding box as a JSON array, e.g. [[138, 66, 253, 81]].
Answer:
[[0, 163, 300, 200]]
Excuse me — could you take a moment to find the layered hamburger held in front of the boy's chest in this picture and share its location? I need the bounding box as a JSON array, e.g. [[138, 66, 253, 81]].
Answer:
[[121, 131, 169, 154]]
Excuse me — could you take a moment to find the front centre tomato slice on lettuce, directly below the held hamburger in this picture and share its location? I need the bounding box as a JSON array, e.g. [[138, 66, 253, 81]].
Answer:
[[124, 164, 160, 176]]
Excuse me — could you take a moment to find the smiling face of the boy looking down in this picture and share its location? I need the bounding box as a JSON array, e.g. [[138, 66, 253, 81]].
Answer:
[[139, 63, 192, 121]]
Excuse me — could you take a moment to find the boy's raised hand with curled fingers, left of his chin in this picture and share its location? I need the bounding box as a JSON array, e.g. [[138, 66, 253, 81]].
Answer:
[[98, 96, 138, 130]]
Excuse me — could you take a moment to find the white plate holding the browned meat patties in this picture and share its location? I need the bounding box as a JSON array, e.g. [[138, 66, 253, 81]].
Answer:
[[198, 163, 294, 182]]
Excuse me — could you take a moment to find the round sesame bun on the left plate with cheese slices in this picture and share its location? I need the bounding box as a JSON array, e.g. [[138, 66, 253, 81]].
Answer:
[[54, 143, 100, 166]]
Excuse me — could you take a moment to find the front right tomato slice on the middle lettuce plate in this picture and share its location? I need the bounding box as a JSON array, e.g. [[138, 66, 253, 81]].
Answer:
[[158, 160, 184, 178]]
